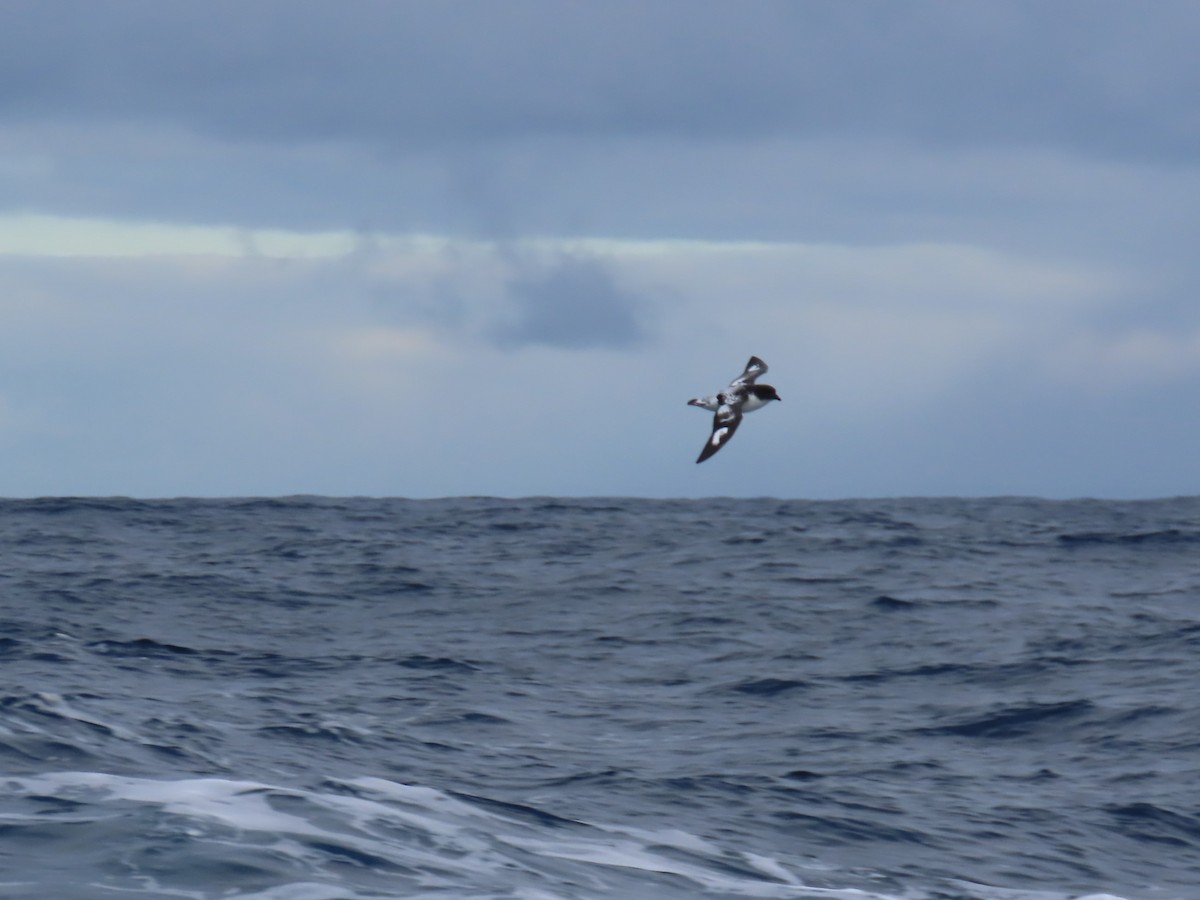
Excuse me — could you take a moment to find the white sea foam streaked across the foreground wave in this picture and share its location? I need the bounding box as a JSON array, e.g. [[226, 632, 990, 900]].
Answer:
[[2, 772, 912, 900]]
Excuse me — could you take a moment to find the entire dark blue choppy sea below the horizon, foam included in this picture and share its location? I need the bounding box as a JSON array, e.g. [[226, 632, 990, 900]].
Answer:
[[0, 497, 1200, 900]]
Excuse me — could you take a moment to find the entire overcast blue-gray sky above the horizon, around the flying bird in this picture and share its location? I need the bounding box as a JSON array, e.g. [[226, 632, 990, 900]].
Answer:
[[0, 0, 1200, 498]]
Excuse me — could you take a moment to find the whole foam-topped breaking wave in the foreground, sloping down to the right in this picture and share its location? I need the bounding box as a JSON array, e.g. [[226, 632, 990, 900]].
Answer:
[[0, 772, 916, 900]]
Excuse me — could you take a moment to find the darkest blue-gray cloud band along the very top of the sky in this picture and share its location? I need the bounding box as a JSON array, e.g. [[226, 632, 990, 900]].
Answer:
[[0, 0, 1200, 163]]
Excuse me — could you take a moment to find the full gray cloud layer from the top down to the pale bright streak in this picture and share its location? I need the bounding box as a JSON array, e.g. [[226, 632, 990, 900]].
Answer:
[[0, 0, 1200, 252]]
